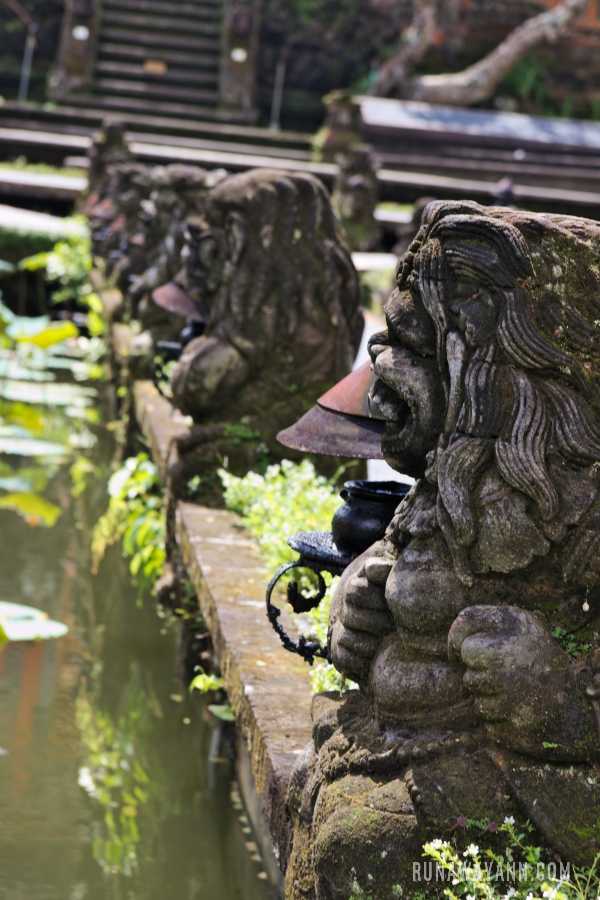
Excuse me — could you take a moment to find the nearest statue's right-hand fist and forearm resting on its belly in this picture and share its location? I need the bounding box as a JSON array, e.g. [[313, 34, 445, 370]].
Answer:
[[448, 606, 600, 762]]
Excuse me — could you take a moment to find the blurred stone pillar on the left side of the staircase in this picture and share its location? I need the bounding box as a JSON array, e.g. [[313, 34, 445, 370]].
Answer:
[[48, 0, 101, 100]]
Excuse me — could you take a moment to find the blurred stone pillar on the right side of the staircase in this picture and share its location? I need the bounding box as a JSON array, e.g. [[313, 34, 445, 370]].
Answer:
[[219, 0, 262, 121]]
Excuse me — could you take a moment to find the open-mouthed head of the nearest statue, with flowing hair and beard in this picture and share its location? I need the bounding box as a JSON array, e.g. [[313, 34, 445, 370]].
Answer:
[[370, 204, 600, 584]]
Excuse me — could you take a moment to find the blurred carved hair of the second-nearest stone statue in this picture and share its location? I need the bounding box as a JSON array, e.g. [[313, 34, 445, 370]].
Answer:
[[191, 170, 363, 374]]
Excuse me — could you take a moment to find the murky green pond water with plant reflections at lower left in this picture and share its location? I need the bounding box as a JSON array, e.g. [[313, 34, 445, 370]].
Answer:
[[0, 390, 269, 900]]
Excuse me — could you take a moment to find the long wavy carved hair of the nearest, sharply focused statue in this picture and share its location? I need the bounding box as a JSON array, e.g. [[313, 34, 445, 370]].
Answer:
[[397, 203, 600, 580]]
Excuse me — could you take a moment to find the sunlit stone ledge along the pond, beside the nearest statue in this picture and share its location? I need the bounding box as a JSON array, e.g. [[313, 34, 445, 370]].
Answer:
[[177, 502, 312, 870]]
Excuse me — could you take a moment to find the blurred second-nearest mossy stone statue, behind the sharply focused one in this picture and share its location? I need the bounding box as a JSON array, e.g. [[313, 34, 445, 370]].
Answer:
[[166, 170, 363, 500]]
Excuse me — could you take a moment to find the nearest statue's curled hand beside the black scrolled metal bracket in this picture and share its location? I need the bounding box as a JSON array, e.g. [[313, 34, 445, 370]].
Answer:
[[329, 548, 394, 683]]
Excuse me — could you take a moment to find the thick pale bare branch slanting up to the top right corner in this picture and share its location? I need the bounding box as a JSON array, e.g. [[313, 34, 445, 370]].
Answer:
[[406, 0, 590, 106]]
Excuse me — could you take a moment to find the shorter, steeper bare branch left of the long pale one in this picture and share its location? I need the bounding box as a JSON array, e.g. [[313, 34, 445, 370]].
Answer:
[[369, 0, 437, 97]]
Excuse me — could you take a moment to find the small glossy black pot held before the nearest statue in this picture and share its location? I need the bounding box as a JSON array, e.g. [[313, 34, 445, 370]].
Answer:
[[331, 481, 410, 555]]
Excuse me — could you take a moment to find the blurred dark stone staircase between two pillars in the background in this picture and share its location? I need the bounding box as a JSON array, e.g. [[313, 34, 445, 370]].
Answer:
[[66, 0, 223, 119]]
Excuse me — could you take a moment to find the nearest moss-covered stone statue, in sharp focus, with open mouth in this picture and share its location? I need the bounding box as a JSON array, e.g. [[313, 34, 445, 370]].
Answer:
[[286, 202, 600, 900]]
